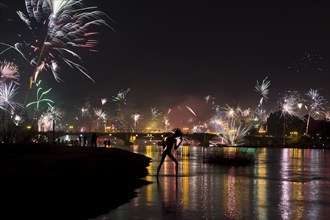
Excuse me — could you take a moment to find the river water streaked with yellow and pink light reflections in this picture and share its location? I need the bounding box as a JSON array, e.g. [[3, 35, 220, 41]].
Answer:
[[93, 145, 330, 219]]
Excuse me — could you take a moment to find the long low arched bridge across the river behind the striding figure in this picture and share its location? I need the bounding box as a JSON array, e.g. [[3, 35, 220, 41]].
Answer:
[[38, 129, 217, 146]]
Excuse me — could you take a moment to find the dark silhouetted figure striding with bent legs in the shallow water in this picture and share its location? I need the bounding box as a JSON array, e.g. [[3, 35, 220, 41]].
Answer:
[[157, 128, 183, 177]]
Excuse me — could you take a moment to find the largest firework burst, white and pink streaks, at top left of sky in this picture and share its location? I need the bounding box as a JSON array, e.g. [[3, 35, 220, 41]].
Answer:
[[2, 0, 111, 83]]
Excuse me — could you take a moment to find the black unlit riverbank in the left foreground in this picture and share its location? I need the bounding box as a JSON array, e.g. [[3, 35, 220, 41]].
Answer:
[[0, 144, 151, 220]]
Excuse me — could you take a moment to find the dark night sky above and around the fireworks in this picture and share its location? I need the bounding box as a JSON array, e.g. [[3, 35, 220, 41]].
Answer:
[[0, 0, 330, 121]]
